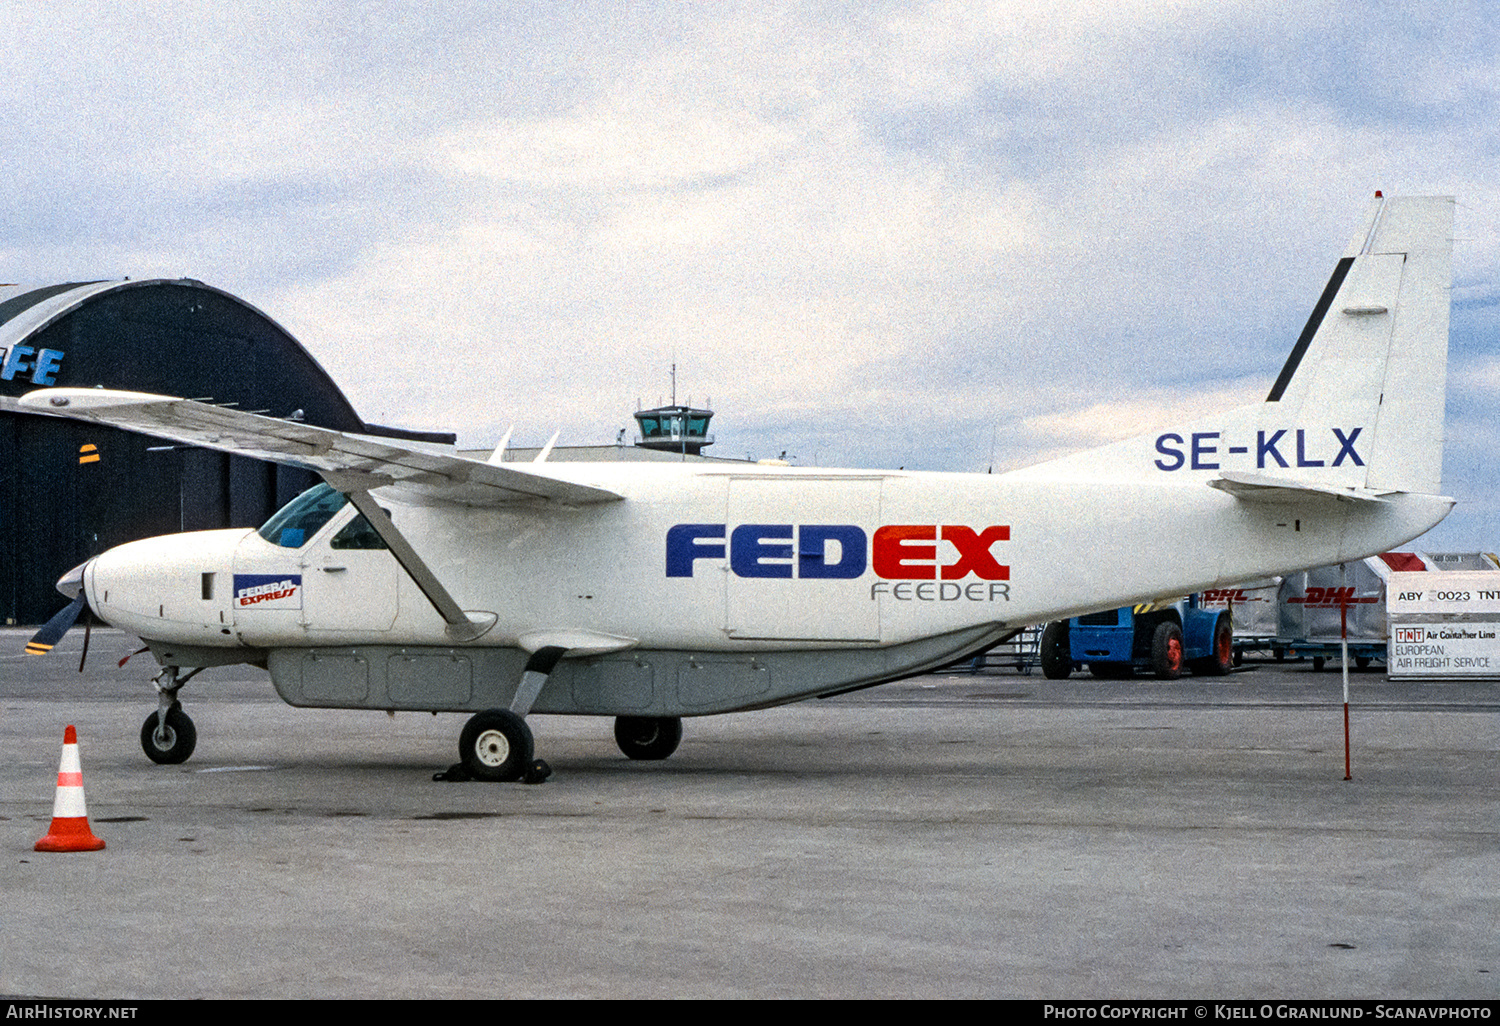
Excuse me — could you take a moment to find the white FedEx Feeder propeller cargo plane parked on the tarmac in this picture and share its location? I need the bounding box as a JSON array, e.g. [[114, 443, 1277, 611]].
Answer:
[[21, 194, 1454, 780]]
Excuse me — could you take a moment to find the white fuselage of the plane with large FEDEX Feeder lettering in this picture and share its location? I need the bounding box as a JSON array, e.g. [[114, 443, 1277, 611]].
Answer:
[[86, 464, 1451, 651]]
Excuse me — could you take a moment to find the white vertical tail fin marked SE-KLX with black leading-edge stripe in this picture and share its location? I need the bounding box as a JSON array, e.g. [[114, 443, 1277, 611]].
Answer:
[[1014, 194, 1454, 495]]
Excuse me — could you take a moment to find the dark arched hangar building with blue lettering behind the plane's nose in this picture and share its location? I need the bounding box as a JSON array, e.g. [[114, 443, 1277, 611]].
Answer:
[[0, 279, 441, 624]]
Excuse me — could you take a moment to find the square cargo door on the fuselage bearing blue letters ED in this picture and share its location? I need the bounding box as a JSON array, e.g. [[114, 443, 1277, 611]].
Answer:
[[725, 476, 881, 642]]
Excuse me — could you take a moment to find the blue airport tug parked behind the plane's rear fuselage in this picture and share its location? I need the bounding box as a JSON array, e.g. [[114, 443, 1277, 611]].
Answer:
[[1040, 596, 1235, 681]]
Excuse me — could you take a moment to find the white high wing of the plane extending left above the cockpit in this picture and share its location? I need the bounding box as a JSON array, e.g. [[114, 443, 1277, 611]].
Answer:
[[17, 389, 623, 506]]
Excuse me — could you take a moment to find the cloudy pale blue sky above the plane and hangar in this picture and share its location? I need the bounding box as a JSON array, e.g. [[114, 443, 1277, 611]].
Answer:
[[0, 0, 1500, 549]]
